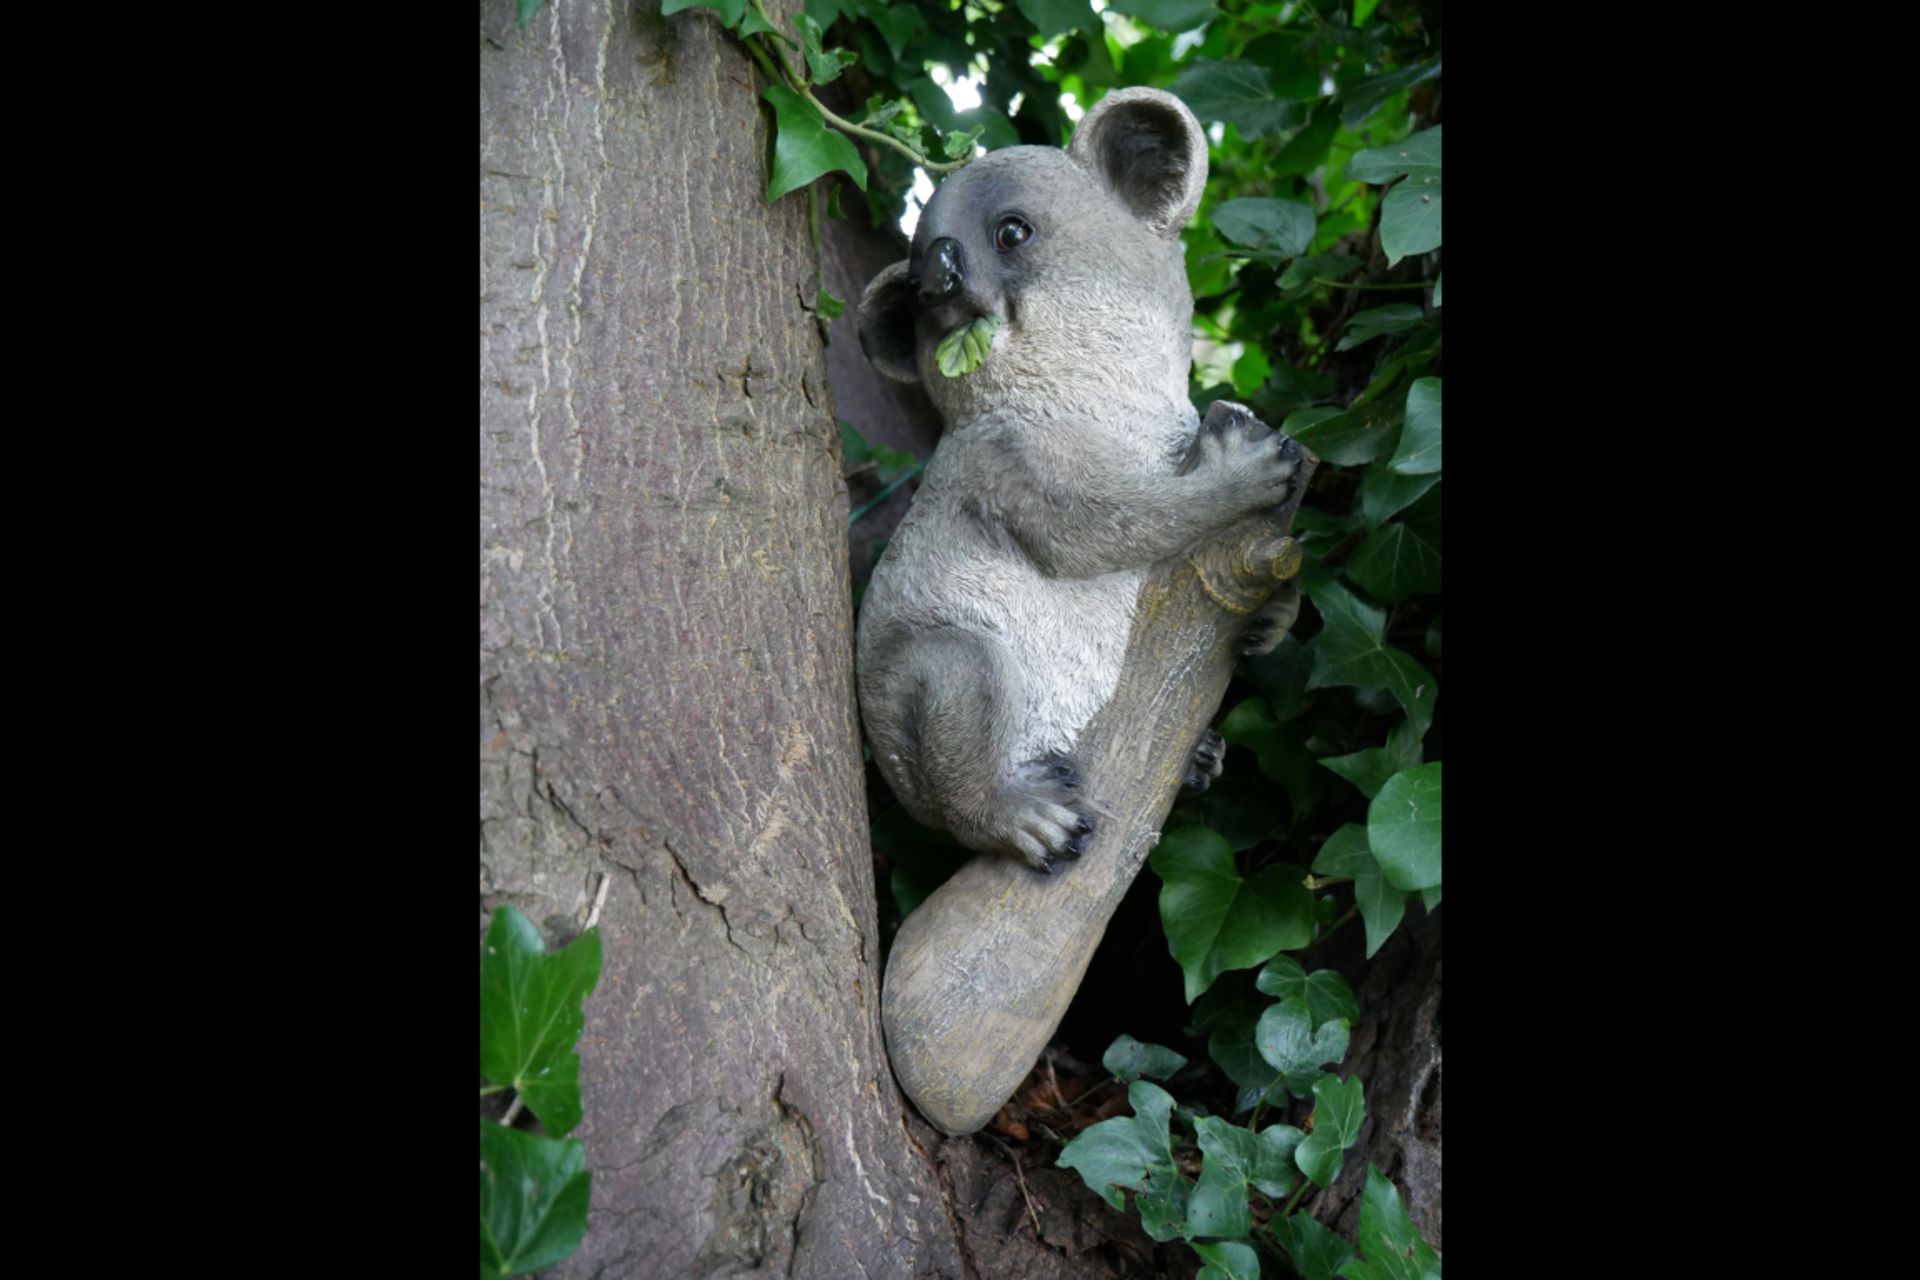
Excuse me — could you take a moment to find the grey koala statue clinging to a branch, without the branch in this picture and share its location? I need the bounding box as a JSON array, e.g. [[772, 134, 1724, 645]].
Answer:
[[856, 88, 1300, 873]]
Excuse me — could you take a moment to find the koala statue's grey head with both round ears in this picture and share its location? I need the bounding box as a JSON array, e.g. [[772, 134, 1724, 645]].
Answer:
[[860, 88, 1206, 424]]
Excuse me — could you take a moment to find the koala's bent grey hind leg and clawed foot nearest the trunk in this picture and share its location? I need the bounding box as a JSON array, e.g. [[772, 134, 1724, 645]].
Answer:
[[876, 629, 1092, 873]]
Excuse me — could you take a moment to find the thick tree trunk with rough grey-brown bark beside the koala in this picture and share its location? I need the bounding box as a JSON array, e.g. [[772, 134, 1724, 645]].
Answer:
[[480, 0, 968, 1280]]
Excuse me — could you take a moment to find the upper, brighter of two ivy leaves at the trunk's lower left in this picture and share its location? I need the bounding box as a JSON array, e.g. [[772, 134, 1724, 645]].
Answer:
[[480, 906, 599, 1138]]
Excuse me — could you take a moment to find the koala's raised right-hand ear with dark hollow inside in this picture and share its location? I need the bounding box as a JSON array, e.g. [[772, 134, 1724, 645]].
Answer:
[[1068, 88, 1206, 240]]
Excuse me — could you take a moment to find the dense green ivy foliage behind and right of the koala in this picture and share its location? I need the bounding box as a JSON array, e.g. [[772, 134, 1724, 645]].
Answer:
[[725, 0, 1444, 1280]]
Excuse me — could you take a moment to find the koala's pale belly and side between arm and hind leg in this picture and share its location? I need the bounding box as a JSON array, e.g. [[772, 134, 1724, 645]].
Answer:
[[862, 512, 1144, 760]]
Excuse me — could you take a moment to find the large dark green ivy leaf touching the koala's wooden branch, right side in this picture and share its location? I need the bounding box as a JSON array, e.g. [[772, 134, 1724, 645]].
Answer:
[[1152, 825, 1313, 1004]]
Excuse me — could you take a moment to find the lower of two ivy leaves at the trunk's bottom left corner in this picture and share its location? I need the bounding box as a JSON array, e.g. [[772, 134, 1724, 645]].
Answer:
[[480, 1120, 593, 1280]]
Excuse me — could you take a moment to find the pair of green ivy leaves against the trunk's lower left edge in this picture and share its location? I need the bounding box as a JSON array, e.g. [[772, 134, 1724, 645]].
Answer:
[[480, 906, 601, 1280]]
